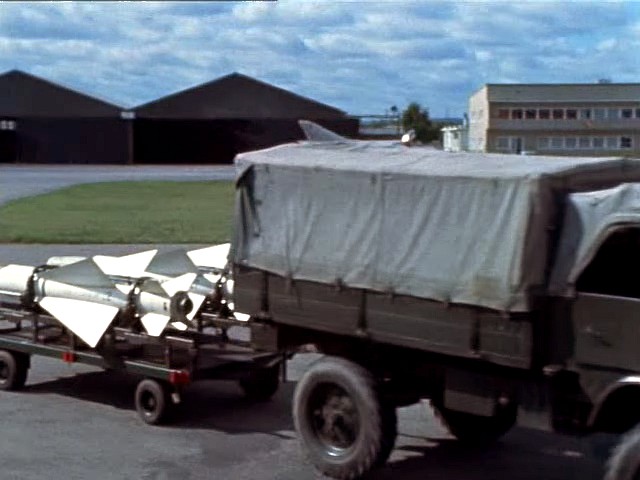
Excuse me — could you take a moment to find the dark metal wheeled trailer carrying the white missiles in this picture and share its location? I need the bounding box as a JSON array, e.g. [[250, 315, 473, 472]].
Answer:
[[0, 306, 284, 424]]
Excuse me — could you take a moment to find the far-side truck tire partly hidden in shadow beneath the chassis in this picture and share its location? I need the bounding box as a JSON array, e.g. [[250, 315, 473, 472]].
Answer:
[[435, 403, 518, 445]]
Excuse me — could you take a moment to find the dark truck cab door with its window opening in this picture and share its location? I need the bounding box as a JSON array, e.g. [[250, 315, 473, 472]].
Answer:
[[573, 228, 640, 371]]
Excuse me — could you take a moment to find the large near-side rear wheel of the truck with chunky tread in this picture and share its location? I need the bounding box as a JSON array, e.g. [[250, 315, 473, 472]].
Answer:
[[293, 357, 397, 479]]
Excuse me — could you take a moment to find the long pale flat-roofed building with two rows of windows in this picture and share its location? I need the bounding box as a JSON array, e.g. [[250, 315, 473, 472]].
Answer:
[[469, 83, 640, 156]]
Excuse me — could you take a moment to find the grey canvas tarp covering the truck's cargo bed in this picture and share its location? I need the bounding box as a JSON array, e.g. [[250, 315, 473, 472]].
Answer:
[[231, 141, 640, 312]]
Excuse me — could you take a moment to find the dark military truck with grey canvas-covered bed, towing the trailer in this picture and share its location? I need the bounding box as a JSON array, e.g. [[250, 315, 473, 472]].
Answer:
[[231, 139, 640, 480]]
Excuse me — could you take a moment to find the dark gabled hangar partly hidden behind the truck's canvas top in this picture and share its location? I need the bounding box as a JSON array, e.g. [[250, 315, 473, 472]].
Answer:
[[133, 73, 358, 164]]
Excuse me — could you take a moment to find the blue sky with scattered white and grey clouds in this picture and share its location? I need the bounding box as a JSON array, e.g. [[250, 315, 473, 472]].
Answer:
[[0, 0, 640, 117]]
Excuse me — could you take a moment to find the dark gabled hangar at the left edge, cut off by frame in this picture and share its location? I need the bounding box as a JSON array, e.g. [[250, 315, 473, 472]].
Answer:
[[0, 70, 131, 164]]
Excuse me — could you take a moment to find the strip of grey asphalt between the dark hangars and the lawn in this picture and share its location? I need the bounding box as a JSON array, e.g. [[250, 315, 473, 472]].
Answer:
[[0, 164, 234, 204]]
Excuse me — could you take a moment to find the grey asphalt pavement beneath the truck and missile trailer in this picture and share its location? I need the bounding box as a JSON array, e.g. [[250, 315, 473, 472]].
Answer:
[[0, 245, 602, 480]]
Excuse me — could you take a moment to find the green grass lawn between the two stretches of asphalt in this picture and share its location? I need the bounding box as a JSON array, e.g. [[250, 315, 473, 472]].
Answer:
[[0, 181, 234, 244]]
